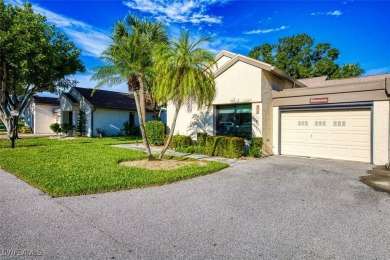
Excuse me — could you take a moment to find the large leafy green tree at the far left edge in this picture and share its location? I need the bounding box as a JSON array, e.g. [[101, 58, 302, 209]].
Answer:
[[0, 0, 85, 135]]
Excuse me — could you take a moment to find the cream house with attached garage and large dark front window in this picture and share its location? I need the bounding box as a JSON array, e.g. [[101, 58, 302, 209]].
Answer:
[[167, 51, 390, 164]]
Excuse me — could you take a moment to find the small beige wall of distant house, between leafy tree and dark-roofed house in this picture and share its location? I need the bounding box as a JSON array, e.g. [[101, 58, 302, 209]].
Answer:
[[33, 104, 58, 134]]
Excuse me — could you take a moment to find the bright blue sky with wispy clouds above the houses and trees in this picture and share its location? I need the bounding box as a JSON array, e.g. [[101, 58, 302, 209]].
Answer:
[[5, 0, 390, 92]]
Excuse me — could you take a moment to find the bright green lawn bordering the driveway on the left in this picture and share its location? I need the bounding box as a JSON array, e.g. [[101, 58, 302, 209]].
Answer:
[[0, 137, 227, 197]]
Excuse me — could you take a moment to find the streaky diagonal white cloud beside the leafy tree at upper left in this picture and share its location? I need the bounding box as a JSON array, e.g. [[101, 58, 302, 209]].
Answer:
[[7, 0, 111, 57]]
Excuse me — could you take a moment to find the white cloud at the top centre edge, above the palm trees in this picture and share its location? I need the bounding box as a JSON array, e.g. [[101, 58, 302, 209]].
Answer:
[[123, 0, 231, 25]]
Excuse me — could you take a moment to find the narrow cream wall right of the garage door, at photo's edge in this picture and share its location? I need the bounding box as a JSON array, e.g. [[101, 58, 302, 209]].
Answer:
[[373, 101, 390, 165]]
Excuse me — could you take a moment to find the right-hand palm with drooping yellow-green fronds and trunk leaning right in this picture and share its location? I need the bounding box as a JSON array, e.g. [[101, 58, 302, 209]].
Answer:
[[153, 31, 215, 160]]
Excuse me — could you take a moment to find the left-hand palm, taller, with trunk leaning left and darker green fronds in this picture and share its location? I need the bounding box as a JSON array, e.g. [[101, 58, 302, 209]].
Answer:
[[92, 15, 167, 160]]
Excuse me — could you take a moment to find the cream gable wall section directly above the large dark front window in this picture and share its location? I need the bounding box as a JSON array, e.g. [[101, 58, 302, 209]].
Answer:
[[213, 61, 261, 105]]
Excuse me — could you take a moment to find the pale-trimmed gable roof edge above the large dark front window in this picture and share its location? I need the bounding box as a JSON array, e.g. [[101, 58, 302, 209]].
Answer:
[[214, 51, 306, 87]]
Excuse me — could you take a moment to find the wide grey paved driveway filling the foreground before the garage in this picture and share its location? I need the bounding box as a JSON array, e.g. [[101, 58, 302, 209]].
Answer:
[[0, 156, 390, 259]]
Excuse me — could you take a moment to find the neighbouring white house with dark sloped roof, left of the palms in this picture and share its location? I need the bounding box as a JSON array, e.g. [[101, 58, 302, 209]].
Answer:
[[60, 87, 166, 136]]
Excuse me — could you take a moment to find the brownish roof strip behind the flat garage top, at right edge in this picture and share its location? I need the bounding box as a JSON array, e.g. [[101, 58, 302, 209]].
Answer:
[[299, 73, 390, 87]]
